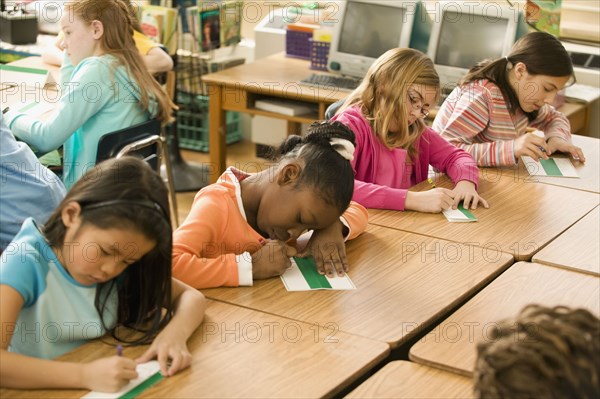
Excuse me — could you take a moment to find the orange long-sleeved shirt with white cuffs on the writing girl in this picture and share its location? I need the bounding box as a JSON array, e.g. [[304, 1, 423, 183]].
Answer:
[[173, 168, 368, 288]]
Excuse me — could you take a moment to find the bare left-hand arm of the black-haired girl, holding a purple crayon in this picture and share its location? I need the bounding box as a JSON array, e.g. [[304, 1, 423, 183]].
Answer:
[[0, 284, 137, 392]]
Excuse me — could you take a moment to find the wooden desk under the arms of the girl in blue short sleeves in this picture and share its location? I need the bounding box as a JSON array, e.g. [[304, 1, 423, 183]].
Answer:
[[0, 301, 389, 398]]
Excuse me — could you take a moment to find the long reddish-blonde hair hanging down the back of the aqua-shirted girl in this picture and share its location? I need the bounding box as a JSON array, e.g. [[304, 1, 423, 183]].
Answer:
[[65, 0, 177, 125]]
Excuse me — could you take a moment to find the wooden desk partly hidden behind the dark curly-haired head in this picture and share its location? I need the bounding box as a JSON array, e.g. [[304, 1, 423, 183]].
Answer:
[[410, 262, 600, 376]]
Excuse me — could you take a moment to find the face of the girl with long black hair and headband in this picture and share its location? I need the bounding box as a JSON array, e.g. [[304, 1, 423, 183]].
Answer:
[[59, 205, 156, 285]]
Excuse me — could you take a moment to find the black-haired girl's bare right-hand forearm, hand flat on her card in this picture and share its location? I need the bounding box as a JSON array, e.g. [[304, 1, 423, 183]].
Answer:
[[137, 279, 206, 376]]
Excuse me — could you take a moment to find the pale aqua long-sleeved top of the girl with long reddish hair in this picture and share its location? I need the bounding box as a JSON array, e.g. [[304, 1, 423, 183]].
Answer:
[[6, 55, 152, 188]]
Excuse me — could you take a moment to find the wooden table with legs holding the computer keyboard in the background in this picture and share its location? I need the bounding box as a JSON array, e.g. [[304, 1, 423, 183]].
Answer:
[[202, 53, 348, 182]]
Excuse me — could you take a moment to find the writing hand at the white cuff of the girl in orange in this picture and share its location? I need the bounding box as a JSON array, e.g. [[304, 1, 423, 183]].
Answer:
[[252, 240, 297, 280]]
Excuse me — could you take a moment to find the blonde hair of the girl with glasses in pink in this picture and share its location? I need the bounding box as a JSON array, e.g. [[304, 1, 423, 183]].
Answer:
[[337, 48, 440, 155]]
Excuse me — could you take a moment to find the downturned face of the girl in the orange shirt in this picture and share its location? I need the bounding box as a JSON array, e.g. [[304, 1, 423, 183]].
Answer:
[[256, 178, 340, 242]]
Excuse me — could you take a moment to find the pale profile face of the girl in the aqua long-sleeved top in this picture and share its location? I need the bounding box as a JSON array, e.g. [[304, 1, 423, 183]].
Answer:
[[60, 12, 102, 66]]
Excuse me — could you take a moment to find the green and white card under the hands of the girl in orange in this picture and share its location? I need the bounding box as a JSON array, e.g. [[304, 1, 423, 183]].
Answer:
[[281, 257, 356, 291]]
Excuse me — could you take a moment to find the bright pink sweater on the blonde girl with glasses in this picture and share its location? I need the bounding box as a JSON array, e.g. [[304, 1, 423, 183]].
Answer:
[[333, 106, 479, 211]]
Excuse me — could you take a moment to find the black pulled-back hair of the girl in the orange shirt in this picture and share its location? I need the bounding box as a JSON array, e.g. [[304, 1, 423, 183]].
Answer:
[[274, 121, 356, 214]]
